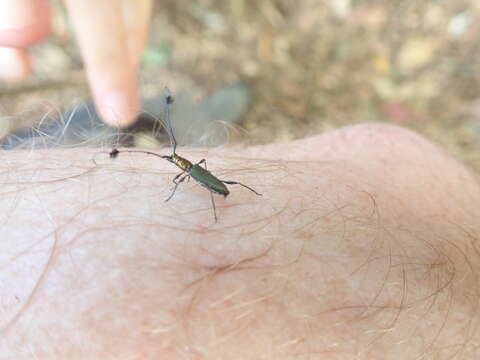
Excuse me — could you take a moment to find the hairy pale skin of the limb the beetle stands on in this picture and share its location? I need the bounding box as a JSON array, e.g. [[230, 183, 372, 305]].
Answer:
[[0, 125, 480, 360]]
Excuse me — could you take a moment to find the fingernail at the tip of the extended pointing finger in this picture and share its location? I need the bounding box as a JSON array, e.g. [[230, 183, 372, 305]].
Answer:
[[98, 92, 139, 126]]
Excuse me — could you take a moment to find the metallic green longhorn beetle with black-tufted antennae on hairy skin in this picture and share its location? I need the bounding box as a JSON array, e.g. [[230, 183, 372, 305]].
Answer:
[[110, 88, 262, 222]]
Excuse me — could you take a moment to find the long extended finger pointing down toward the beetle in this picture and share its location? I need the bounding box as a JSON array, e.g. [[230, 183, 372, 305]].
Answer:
[[65, 0, 139, 126]]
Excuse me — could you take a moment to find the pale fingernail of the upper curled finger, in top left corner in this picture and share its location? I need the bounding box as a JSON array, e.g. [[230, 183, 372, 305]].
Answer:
[[0, 0, 38, 30]]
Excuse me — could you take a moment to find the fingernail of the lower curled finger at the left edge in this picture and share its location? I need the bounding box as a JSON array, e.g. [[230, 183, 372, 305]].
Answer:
[[0, 46, 31, 81]]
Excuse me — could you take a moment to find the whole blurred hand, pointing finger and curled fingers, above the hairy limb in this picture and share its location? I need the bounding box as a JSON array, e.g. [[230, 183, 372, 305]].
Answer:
[[0, 0, 152, 126]]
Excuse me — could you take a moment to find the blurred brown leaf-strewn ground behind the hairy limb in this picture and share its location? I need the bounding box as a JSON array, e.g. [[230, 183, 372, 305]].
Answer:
[[0, 0, 480, 172]]
